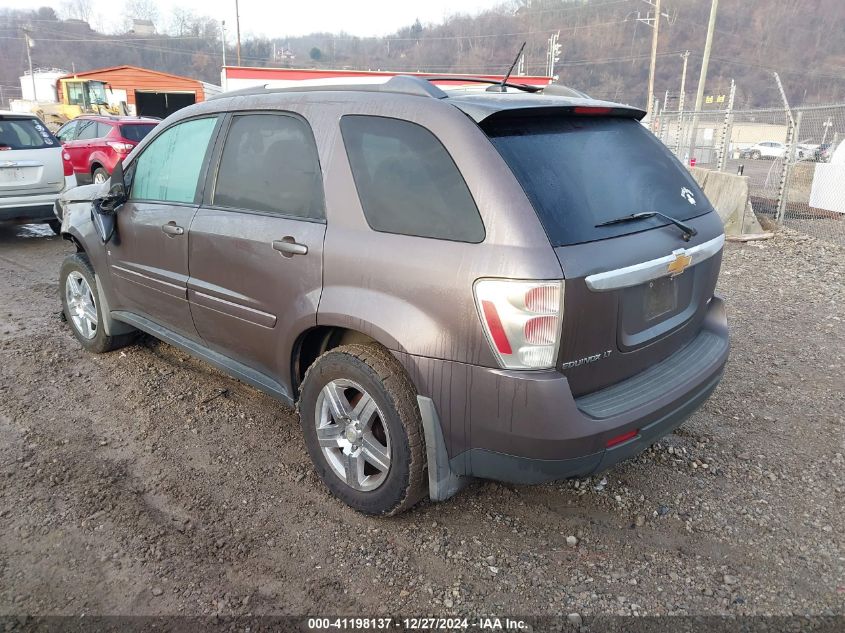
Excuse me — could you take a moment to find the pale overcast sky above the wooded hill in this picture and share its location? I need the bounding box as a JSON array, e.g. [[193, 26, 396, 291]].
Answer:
[[8, 0, 500, 39]]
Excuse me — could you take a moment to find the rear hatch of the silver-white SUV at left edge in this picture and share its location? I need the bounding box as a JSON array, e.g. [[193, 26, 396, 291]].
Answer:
[[0, 114, 65, 197]]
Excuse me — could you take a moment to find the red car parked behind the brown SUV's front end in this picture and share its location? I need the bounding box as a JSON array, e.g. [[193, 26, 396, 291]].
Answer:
[[56, 115, 159, 183]]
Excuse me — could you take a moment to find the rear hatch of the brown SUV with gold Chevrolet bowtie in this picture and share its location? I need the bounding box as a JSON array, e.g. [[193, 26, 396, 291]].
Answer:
[[482, 113, 724, 396]]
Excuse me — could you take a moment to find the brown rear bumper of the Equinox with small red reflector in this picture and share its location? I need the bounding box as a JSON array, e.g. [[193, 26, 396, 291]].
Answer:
[[397, 297, 730, 494]]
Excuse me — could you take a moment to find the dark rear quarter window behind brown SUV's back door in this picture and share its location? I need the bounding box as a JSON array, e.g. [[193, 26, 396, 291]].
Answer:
[[340, 115, 484, 243]]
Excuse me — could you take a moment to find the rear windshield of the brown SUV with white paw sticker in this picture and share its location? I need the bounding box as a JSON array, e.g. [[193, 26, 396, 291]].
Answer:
[[485, 117, 712, 246]]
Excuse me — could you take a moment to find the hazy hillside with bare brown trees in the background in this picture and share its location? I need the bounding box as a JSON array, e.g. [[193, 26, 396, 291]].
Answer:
[[0, 0, 845, 107]]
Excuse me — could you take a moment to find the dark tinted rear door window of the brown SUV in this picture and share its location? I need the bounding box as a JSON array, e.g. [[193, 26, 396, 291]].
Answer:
[[213, 114, 324, 219]]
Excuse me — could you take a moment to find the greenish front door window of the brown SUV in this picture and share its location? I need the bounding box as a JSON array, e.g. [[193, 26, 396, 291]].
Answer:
[[129, 117, 217, 203]]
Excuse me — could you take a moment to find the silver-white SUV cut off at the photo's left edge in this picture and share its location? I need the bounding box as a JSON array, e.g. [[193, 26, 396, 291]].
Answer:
[[0, 110, 76, 233]]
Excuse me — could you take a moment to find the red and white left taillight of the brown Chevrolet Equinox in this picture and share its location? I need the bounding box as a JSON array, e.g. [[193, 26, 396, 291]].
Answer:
[[473, 279, 563, 369]]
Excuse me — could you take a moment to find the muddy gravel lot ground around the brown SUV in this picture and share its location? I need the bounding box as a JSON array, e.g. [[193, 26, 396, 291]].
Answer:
[[0, 222, 845, 621]]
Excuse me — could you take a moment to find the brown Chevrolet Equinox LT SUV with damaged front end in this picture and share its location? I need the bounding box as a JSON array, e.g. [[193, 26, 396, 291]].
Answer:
[[58, 77, 729, 514]]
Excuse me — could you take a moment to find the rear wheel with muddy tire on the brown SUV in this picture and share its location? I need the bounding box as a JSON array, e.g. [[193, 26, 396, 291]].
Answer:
[[297, 344, 427, 515]]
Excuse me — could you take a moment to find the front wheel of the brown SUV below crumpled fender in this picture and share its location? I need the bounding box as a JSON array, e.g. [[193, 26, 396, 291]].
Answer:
[[59, 253, 132, 354]]
